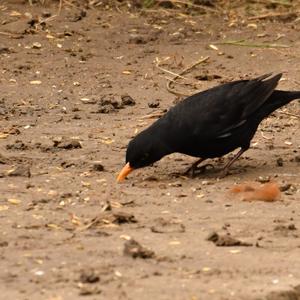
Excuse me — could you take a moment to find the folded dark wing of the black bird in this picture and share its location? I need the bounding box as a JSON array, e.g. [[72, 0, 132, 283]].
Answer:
[[166, 74, 282, 139]]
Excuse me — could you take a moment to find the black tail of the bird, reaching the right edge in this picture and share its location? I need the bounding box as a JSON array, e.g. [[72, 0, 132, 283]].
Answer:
[[263, 90, 300, 116]]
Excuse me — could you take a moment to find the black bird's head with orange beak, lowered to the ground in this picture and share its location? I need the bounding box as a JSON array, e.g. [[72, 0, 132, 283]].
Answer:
[[117, 130, 168, 182]]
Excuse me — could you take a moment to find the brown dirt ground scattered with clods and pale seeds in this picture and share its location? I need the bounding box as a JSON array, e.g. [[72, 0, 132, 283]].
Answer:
[[0, 0, 300, 300]]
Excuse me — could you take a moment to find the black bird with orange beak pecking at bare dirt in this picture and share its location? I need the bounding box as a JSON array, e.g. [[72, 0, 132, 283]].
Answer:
[[117, 74, 300, 181]]
